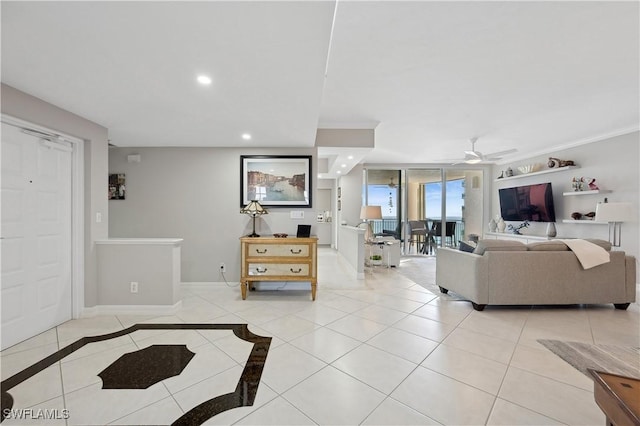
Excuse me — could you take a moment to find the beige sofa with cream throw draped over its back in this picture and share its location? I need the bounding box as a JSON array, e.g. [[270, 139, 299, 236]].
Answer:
[[436, 240, 636, 311]]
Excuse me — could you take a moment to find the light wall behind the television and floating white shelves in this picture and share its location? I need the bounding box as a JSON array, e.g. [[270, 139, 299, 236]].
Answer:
[[485, 132, 640, 280]]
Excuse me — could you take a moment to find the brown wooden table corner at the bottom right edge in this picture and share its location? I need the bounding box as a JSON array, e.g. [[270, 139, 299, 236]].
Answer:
[[589, 369, 640, 426]]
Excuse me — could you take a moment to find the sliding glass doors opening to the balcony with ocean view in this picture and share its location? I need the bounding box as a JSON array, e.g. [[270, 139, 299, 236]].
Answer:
[[363, 168, 483, 255]]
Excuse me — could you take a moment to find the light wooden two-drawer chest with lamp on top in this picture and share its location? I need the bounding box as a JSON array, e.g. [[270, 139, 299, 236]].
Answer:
[[240, 237, 318, 300]]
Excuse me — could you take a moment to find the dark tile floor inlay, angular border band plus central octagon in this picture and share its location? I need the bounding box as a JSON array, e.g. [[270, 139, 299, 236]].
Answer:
[[0, 324, 271, 425]]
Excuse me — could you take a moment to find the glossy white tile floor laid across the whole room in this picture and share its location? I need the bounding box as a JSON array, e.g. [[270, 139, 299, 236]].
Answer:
[[1, 249, 640, 425]]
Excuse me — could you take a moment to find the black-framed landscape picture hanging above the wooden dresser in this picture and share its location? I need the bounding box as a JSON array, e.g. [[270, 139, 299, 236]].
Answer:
[[240, 155, 312, 208]]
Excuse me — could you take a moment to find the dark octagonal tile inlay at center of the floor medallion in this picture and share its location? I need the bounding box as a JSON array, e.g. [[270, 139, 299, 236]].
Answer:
[[98, 345, 195, 389]]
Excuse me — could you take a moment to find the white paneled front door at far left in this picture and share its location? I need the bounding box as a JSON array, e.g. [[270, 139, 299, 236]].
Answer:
[[0, 123, 72, 349]]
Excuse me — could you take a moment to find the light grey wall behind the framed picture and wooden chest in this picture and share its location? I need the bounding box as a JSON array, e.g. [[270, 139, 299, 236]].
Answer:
[[111, 148, 317, 282]]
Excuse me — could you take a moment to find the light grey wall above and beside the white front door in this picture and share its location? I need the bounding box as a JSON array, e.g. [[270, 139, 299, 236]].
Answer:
[[1, 84, 109, 307]]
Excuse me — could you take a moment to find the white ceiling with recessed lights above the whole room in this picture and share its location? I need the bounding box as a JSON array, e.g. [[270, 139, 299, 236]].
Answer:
[[1, 1, 640, 171]]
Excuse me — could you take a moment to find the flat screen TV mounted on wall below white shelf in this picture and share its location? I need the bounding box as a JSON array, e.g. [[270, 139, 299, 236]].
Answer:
[[498, 182, 556, 222]]
